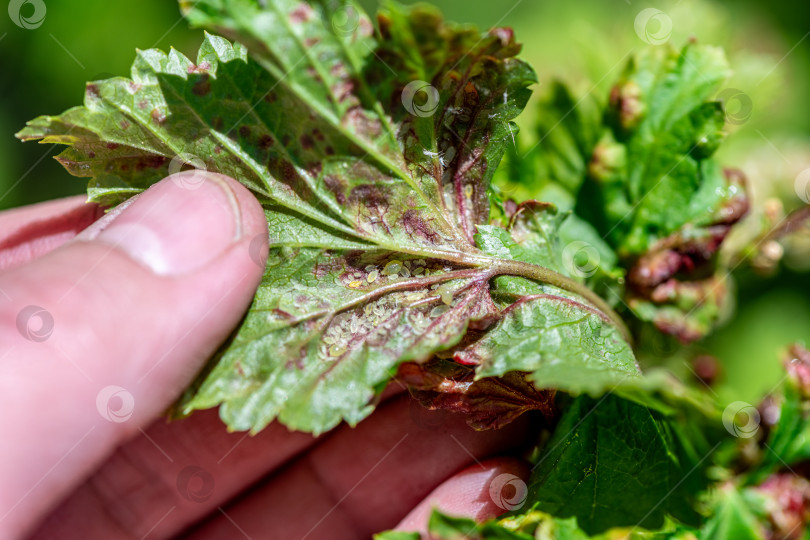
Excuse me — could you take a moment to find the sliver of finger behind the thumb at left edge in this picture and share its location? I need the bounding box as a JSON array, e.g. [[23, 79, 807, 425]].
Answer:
[[0, 195, 103, 271]]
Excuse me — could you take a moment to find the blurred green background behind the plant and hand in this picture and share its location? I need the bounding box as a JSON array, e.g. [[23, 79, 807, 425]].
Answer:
[[0, 0, 810, 401]]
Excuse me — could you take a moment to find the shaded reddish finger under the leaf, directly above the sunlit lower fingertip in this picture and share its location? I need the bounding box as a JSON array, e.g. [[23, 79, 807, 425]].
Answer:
[[184, 396, 529, 540]]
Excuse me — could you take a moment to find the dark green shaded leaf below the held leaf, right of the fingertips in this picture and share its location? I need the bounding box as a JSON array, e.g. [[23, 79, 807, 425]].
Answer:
[[529, 395, 704, 534]]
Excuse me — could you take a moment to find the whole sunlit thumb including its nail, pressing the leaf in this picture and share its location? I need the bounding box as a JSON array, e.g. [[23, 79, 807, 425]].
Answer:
[[0, 171, 267, 536]]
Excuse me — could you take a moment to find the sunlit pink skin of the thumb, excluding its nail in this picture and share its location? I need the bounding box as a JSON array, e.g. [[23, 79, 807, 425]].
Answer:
[[0, 176, 266, 531]]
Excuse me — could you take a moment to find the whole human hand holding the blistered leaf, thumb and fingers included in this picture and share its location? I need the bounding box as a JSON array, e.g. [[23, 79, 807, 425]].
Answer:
[[0, 172, 527, 540]]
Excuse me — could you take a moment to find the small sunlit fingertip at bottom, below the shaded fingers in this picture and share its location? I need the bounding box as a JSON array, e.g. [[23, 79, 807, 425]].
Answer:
[[395, 458, 529, 538]]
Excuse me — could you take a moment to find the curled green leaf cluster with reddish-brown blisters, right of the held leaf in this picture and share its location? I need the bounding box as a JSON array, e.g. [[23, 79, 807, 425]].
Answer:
[[510, 44, 748, 342]]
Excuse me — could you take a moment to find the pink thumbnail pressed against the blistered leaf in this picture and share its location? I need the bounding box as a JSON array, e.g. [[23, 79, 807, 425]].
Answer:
[[96, 171, 242, 275]]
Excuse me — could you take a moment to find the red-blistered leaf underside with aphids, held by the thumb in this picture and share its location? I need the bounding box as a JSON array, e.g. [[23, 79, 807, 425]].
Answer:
[[18, 0, 637, 433]]
